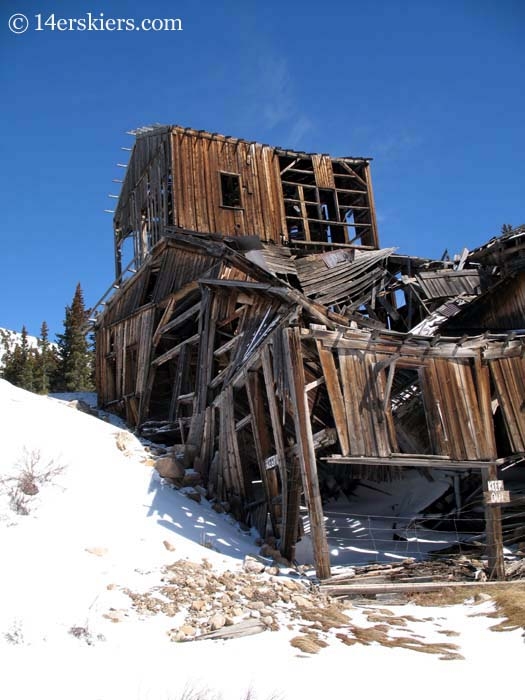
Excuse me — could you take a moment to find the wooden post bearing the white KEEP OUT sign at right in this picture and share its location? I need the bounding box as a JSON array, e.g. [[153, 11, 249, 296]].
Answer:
[[474, 357, 505, 581]]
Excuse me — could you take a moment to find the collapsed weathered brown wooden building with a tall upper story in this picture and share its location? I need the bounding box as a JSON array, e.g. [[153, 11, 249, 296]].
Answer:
[[96, 127, 525, 578]]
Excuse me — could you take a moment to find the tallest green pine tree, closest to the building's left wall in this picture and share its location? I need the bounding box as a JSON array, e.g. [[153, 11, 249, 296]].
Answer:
[[57, 283, 93, 391]]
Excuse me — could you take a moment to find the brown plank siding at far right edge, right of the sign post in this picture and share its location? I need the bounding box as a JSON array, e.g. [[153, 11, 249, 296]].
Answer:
[[489, 357, 525, 452]]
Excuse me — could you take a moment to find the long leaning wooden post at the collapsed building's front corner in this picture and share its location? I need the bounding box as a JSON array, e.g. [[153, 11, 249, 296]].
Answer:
[[283, 328, 331, 579]]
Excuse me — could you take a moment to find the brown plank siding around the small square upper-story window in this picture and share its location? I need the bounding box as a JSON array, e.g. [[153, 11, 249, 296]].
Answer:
[[172, 129, 284, 243]]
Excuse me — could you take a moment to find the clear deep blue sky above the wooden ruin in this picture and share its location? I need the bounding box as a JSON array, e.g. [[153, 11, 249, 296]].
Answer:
[[0, 0, 525, 334]]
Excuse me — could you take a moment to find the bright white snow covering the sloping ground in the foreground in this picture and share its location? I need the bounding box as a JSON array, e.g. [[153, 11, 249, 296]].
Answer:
[[0, 380, 525, 700]]
